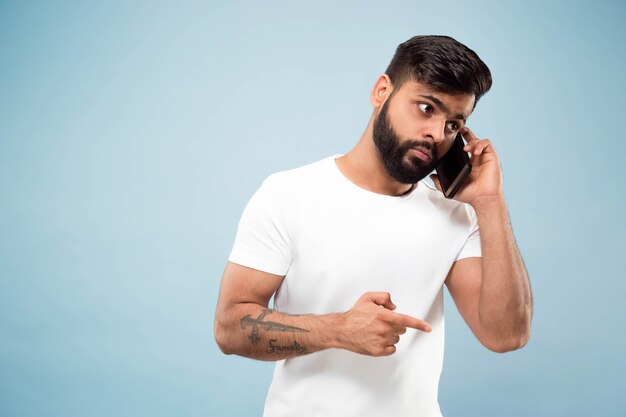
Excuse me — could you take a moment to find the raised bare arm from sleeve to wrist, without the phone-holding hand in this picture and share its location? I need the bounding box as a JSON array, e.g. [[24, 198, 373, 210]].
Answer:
[[446, 205, 532, 353]]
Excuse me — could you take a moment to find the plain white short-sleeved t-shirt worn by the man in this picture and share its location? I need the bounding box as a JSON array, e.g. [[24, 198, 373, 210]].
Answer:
[[229, 156, 481, 417]]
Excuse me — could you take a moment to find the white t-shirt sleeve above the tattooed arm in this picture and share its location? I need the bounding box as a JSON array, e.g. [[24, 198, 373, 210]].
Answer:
[[228, 176, 291, 275]]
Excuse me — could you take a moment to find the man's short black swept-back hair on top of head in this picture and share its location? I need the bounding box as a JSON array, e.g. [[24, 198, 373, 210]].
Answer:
[[385, 35, 491, 106]]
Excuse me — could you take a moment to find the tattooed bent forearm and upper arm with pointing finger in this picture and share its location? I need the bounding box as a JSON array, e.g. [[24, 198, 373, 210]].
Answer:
[[214, 262, 431, 360]]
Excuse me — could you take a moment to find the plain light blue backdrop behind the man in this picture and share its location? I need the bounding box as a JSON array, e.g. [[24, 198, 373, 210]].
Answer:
[[0, 1, 626, 417]]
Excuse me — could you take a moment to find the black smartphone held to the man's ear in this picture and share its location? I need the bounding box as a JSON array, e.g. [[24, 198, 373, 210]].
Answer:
[[435, 133, 472, 198]]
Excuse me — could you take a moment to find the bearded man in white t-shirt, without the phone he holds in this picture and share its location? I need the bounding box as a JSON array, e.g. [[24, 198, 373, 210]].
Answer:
[[215, 36, 532, 417]]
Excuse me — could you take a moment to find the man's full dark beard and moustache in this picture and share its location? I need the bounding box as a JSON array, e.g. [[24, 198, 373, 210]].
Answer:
[[372, 98, 439, 184]]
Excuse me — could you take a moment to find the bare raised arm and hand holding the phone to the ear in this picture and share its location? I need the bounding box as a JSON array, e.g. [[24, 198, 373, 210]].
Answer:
[[433, 129, 533, 352]]
